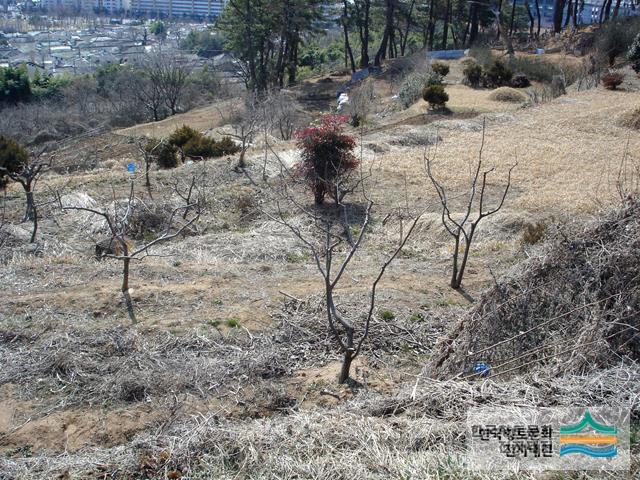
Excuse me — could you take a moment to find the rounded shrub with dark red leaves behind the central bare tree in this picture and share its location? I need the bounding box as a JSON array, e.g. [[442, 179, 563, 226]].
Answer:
[[295, 115, 360, 205]]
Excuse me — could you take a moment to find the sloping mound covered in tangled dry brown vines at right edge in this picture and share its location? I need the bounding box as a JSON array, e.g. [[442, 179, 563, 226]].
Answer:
[[430, 200, 640, 377]]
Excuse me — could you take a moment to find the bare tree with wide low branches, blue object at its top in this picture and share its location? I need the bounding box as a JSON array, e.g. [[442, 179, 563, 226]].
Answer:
[[58, 182, 200, 323]]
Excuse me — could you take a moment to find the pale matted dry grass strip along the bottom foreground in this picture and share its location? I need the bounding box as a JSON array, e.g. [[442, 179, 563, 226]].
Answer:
[[5, 367, 640, 480]]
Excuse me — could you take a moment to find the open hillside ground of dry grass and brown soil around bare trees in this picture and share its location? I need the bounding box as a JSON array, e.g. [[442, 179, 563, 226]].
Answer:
[[0, 55, 640, 479]]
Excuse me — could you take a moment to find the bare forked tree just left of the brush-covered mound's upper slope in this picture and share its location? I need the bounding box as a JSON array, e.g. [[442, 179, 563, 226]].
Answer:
[[424, 123, 517, 290]]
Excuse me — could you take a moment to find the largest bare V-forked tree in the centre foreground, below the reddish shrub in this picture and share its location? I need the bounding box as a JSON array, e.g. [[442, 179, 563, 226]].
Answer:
[[265, 152, 421, 384]]
